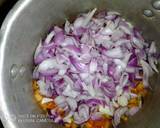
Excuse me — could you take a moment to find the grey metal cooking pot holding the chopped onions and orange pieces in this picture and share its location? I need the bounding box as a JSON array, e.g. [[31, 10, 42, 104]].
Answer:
[[0, 0, 160, 128]]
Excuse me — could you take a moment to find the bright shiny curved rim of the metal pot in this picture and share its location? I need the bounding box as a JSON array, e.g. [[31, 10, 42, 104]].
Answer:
[[0, 0, 32, 128]]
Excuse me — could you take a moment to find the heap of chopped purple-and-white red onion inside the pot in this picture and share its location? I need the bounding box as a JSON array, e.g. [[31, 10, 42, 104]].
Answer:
[[33, 9, 159, 127]]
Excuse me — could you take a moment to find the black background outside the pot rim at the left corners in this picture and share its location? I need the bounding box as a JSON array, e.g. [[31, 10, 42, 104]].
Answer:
[[0, 0, 18, 128]]
